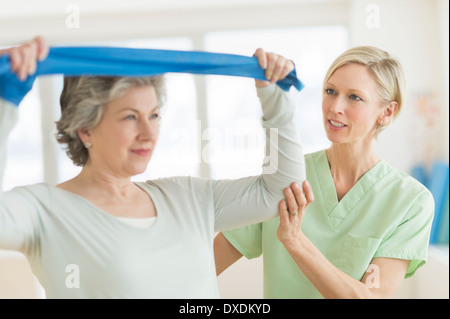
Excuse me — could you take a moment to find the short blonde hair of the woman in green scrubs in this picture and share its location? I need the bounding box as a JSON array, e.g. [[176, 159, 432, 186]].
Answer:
[[323, 46, 405, 136]]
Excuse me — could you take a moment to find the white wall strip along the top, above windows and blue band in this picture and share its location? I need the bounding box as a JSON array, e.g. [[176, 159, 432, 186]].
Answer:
[[0, 0, 348, 45]]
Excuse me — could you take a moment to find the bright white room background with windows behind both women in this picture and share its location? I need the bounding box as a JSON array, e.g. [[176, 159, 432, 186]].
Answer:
[[0, 0, 449, 298]]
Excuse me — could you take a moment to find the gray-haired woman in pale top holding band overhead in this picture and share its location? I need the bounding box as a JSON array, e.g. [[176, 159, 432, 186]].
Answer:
[[0, 38, 304, 298]]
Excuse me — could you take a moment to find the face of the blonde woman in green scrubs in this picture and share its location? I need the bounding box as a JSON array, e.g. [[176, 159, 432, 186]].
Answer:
[[322, 63, 383, 148]]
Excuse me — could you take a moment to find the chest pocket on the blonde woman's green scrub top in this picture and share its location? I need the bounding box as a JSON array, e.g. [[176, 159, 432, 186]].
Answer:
[[333, 235, 381, 280]]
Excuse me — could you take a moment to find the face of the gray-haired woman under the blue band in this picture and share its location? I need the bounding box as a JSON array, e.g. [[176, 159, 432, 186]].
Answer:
[[84, 86, 159, 177]]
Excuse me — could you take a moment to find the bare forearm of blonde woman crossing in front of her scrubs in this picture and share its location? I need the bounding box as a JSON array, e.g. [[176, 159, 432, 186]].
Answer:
[[284, 234, 375, 299]]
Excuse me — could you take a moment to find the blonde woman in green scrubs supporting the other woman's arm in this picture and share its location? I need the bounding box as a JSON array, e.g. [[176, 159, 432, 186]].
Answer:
[[215, 47, 434, 298]]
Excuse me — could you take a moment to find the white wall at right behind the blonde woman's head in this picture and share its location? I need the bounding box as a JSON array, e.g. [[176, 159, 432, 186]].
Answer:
[[349, 0, 449, 172]]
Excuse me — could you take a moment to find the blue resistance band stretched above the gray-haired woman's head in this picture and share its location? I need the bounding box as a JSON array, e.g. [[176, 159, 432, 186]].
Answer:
[[0, 47, 303, 105]]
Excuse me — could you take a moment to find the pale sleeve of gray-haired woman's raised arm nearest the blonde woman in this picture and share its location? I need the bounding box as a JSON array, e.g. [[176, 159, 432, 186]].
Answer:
[[211, 84, 306, 231]]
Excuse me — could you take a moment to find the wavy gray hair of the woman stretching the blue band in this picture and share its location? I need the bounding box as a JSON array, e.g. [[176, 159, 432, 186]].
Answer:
[[56, 76, 166, 166]]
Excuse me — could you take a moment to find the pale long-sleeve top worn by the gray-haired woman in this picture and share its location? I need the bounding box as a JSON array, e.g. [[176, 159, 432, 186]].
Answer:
[[0, 85, 305, 298]]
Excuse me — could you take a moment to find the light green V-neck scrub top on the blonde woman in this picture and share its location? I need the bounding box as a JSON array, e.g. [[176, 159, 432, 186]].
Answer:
[[223, 150, 434, 298]]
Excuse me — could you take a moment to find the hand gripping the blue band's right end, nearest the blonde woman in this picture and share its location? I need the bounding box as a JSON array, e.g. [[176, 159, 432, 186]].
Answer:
[[254, 48, 294, 83]]
